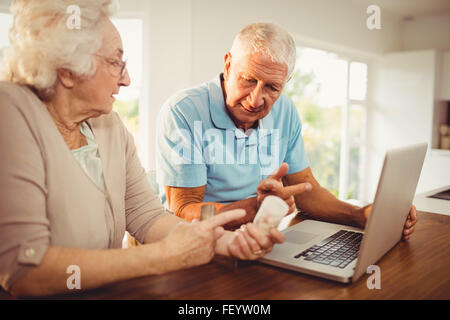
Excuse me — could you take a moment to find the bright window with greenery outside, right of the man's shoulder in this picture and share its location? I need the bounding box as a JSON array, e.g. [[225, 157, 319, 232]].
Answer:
[[285, 47, 367, 200]]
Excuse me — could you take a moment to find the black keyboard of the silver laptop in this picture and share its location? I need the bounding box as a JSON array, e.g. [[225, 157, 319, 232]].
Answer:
[[295, 230, 363, 269]]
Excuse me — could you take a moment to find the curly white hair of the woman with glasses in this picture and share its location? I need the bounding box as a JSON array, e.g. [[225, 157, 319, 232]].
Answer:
[[1, 0, 118, 100]]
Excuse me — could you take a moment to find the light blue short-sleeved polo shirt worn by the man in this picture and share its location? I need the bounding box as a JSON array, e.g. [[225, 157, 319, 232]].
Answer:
[[156, 75, 308, 203]]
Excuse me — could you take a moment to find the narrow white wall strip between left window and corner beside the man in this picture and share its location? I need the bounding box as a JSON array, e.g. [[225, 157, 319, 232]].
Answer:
[[140, 0, 191, 169]]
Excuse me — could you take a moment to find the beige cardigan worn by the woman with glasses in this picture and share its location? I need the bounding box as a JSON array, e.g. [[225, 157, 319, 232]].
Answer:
[[0, 82, 167, 290]]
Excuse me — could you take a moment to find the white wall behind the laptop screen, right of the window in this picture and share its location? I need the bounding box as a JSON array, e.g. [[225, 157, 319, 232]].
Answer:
[[364, 50, 450, 201]]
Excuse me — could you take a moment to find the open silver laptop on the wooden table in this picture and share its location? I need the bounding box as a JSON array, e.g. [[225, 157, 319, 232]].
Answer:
[[259, 143, 427, 283]]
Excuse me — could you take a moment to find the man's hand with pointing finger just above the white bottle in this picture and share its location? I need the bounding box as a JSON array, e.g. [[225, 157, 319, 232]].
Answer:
[[256, 162, 312, 214]]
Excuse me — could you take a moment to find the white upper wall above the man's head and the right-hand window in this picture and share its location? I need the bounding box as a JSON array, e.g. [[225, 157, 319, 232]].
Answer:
[[191, 0, 400, 84]]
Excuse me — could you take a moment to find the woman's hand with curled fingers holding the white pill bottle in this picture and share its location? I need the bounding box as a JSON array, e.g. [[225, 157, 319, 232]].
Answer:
[[227, 223, 285, 260]]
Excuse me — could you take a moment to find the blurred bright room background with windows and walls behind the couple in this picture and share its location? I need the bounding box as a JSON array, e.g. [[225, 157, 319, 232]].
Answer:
[[0, 0, 450, 202]]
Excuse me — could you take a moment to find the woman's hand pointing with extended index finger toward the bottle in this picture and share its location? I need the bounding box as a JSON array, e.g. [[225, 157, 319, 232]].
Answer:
[[161, 209, 245, 272]]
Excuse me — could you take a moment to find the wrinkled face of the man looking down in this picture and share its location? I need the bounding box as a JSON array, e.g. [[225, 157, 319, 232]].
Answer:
[[223, 52, 288, 131]]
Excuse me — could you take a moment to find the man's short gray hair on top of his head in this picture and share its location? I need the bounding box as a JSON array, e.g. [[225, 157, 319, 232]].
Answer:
[[230, 22, 296, 79]]
